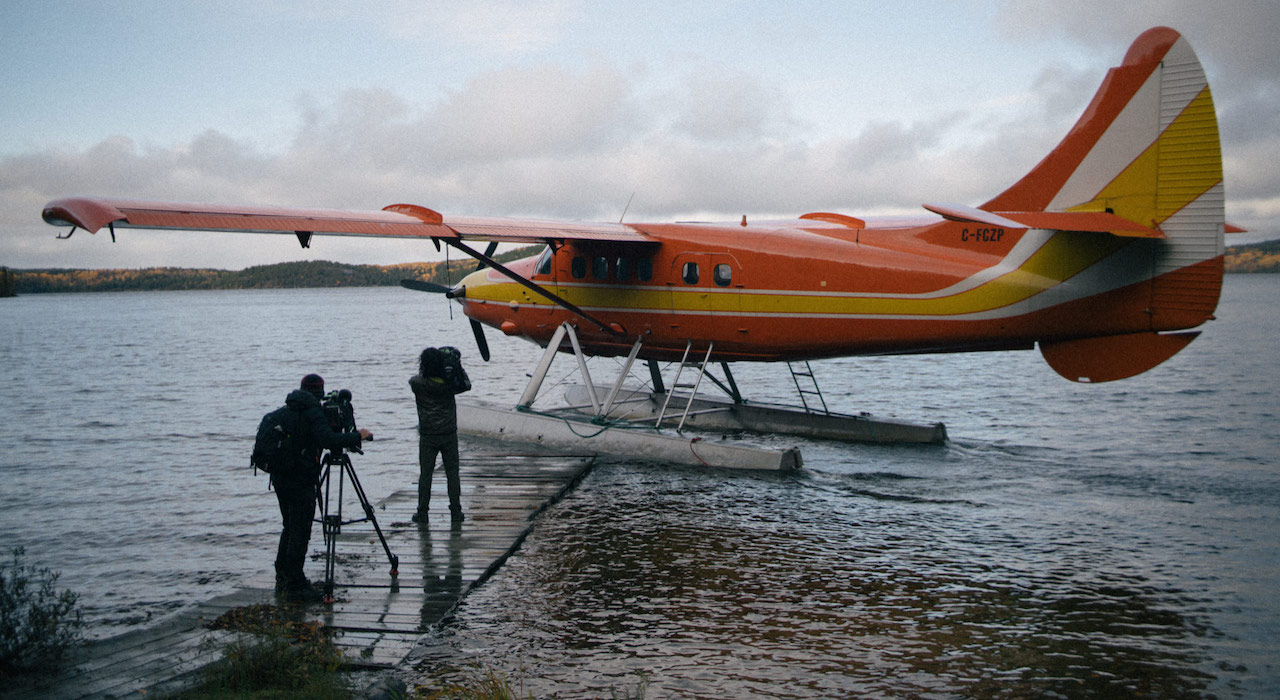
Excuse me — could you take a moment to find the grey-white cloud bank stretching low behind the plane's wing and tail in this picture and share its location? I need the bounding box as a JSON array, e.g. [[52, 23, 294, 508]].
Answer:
[[0, 5, 1280, 266]]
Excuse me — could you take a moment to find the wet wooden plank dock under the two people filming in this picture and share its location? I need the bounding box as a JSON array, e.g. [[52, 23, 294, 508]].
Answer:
[[11, 454, 594, 699]]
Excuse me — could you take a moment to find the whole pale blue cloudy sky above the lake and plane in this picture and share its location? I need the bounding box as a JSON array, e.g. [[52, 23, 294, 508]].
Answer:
[[0, 0, 1280, 269]]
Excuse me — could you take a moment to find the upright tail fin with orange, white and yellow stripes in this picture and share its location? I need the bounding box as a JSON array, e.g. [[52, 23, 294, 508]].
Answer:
[[980, 27, 1226, 379]]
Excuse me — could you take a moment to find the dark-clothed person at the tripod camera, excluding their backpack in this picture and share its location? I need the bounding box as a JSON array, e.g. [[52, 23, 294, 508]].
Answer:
[[271, 374, 374, 600]]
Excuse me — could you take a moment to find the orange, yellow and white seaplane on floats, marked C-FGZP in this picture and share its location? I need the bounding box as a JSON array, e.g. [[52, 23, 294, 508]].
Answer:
[[44, 27, 1238, 468]]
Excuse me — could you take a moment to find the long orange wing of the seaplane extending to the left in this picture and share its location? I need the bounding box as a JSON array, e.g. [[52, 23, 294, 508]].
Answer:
[[44, 197, 657, 247]]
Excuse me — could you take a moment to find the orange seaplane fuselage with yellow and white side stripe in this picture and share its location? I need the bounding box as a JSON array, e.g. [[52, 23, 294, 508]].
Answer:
[[456, 212, 1221, 379]]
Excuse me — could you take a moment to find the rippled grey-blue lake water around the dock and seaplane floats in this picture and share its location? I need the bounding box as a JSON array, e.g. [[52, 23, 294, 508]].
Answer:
[[0, 275, 1280, 697]]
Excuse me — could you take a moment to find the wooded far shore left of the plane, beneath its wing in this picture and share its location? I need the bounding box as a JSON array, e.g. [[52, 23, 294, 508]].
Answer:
[[0, 246, 540, 294]]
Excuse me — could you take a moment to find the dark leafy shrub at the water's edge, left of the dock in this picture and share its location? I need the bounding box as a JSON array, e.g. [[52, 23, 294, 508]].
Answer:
[[0, 546, 84, 678]]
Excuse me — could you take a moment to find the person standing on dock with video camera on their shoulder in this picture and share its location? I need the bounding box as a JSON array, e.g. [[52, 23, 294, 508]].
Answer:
[[408, 347, 471, 523]]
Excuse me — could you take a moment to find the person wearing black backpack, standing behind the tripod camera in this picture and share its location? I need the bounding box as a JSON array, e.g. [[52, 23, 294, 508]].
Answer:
[[253, 374, 374, 601]]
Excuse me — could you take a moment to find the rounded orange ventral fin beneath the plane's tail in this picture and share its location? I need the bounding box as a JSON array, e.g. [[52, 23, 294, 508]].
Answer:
[[1039, 330, 1199, 383]]
